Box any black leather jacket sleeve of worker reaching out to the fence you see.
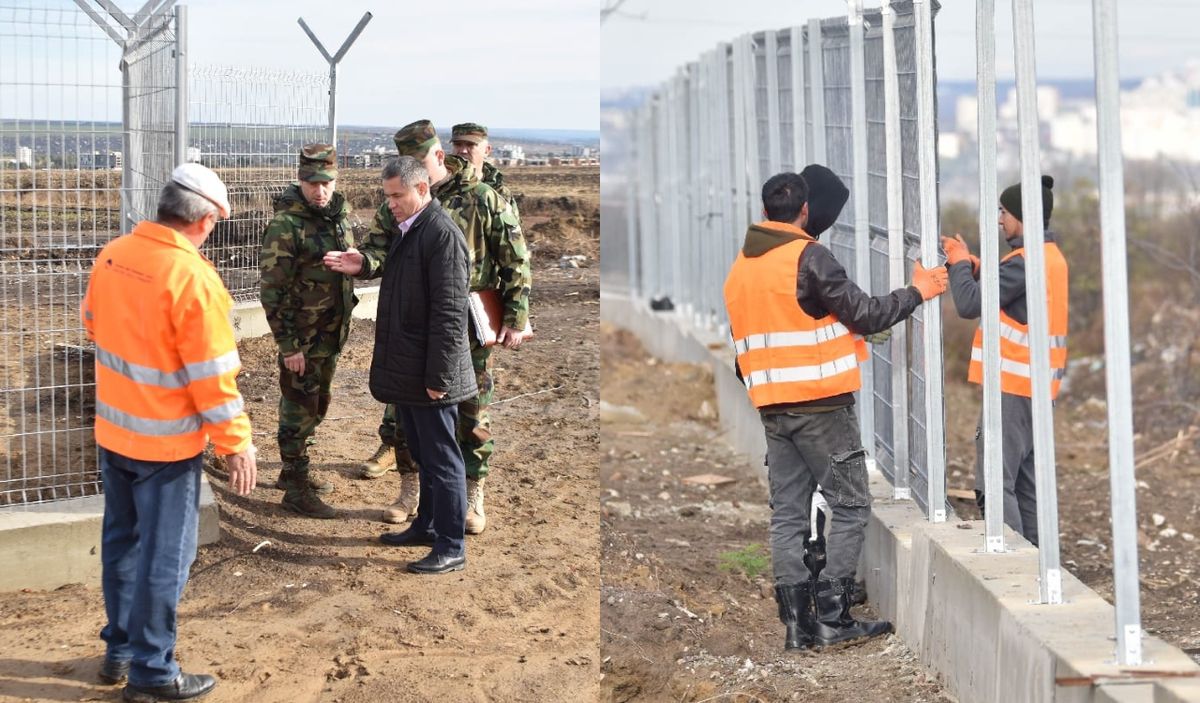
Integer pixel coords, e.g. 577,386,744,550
796,245,923,335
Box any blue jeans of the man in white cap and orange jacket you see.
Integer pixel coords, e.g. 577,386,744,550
100,447,202,686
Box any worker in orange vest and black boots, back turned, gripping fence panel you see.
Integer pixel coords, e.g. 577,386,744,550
725,164,947,649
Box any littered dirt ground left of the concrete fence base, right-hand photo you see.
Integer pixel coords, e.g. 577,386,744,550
600,324,954,703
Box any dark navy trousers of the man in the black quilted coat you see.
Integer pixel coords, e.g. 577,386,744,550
396,405,467,557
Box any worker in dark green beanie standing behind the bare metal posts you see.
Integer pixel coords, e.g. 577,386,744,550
942,175,1068,546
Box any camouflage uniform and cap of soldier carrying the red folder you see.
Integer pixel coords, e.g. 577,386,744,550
359,126,532,479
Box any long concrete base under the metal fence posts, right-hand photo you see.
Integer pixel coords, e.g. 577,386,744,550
600,293,1200,703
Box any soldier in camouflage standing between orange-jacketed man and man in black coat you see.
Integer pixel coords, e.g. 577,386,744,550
259,144,358,518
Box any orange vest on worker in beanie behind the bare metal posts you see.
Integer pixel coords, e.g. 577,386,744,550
967,241,1067,399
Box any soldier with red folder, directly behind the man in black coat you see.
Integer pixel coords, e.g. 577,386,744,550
359,120,532,534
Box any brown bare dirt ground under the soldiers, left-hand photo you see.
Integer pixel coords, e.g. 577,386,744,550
0,169,600,703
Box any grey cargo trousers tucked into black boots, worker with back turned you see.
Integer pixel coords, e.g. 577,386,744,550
762,407,871,585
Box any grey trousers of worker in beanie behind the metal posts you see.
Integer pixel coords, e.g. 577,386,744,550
976,393,1038,547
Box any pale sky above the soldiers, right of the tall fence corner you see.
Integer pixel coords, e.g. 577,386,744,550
188,0,600,130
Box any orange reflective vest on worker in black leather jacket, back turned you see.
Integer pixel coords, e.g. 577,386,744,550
725,222,870,408
